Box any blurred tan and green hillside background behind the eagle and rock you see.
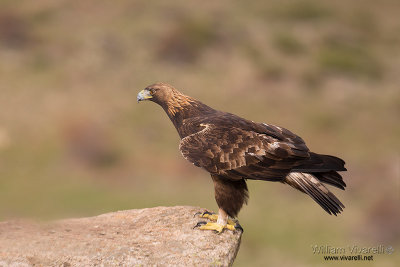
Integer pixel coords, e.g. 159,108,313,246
0,0,400,266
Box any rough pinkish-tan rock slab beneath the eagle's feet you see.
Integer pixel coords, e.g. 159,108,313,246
0,207,242,266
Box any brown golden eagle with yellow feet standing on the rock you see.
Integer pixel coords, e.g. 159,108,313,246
137,83,346,233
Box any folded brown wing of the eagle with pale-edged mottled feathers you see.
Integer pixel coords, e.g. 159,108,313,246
179,124,309,181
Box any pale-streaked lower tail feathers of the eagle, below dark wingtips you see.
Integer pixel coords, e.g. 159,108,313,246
284,172,344,216
